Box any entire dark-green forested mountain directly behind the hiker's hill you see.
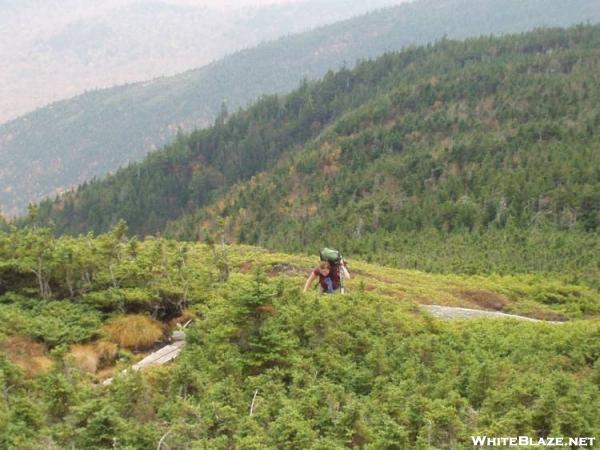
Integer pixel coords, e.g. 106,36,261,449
31,26,600,287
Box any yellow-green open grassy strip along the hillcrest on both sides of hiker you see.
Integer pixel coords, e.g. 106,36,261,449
226,246,600,320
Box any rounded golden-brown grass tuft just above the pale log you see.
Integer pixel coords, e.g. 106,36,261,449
104,314,163,350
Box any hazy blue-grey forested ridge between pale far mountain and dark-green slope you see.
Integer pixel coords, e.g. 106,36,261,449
0,0,600,214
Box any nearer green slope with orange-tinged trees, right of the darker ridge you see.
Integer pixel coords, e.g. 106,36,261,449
169,27,600,287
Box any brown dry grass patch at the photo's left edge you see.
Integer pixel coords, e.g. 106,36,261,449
0,336,52,377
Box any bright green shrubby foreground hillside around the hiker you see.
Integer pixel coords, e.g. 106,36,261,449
0,225,600,450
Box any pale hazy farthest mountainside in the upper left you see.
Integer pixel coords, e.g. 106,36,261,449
0,0,402,123
